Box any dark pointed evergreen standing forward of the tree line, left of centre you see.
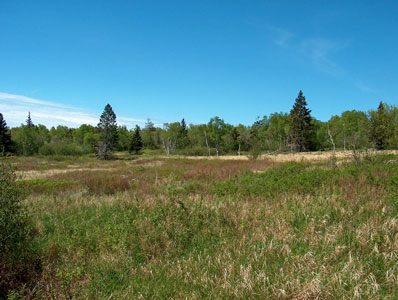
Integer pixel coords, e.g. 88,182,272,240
97,104,117,159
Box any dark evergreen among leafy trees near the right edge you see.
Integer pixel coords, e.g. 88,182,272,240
370,101,393,150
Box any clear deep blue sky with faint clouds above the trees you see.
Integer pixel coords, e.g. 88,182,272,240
0,0,398,128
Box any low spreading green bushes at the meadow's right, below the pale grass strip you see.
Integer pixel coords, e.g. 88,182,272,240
213,159,398,198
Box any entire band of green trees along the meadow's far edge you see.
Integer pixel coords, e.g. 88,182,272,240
0,91,398,159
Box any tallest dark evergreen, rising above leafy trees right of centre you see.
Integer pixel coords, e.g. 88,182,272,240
289,90,313,152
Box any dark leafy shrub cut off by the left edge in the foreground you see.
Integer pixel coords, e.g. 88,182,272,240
0,162,40,298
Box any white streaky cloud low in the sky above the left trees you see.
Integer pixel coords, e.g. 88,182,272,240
0,92,154,128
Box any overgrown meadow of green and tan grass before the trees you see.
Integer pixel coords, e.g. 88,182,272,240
4,154,398,299
